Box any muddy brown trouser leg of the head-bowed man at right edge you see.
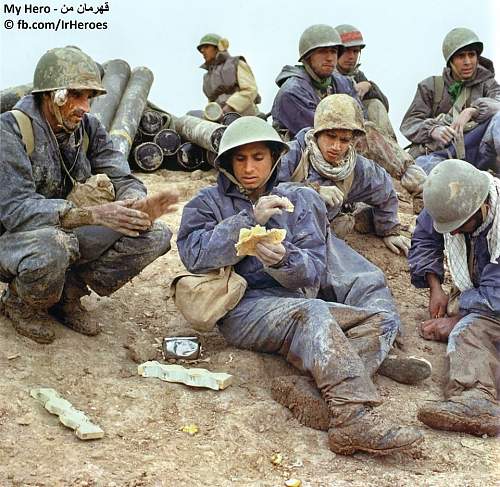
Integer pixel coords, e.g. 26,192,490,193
444,313,500,400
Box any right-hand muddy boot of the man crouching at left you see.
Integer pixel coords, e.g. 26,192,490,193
50,273,101,336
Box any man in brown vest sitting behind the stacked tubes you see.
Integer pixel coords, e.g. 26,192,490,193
191,34,260,115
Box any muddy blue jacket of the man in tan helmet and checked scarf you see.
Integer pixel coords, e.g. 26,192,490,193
278,128,399,237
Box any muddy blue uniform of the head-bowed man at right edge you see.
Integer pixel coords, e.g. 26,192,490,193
409,210,500,399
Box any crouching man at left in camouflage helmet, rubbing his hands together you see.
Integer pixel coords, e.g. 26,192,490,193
0,47,176,343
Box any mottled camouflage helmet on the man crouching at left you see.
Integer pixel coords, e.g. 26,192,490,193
32,46,106,95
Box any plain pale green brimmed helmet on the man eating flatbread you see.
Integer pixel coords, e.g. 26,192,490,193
215,117,288,167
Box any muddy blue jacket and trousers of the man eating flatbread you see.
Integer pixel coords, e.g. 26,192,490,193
177,166,400,406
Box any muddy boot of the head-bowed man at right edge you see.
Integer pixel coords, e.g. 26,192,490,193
417,395,500,436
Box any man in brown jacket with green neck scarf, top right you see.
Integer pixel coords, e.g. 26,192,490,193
401,27,500,173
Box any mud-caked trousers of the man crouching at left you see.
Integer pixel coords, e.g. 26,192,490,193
0,222,172,308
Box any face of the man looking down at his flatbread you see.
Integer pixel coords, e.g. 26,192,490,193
231,142,273,190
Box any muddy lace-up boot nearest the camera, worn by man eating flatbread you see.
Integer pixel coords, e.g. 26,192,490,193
328,405,423,455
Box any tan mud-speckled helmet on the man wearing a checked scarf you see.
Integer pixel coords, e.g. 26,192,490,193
314,94,365,135
